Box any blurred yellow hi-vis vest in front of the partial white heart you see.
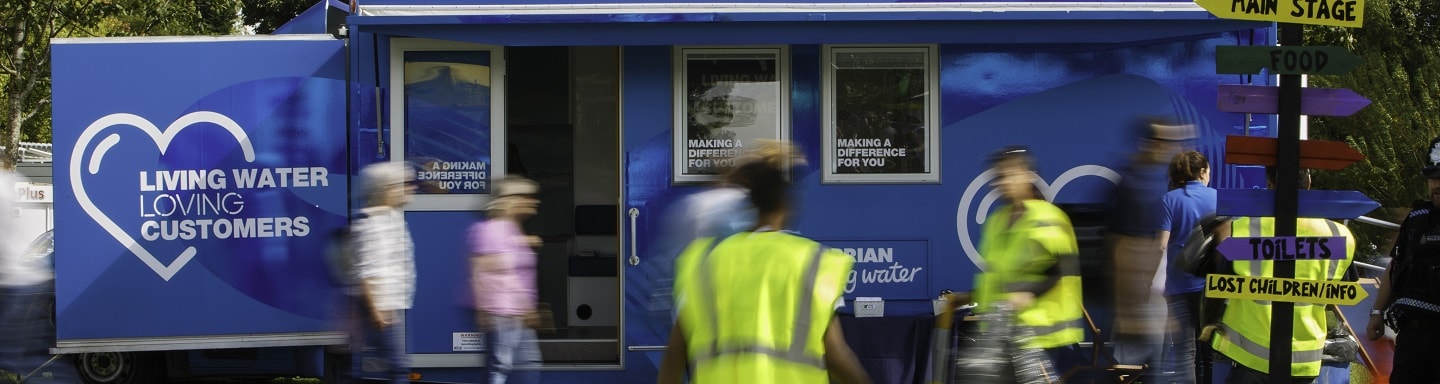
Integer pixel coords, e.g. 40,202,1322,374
975,200,1084,348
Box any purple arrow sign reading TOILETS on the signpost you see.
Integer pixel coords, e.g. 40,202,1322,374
1215,236,1345,262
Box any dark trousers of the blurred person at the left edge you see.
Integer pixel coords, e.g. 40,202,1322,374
0,283,81,383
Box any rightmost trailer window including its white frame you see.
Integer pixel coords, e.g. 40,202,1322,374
821,46,940,183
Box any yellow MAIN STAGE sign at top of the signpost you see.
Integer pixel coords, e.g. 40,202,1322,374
1195,0,1365,27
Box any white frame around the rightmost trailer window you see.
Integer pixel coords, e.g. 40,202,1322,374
821,45,940,184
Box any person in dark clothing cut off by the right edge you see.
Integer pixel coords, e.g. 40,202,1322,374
1367,137,1440,384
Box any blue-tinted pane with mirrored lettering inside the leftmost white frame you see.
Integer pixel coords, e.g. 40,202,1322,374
405,50,491,194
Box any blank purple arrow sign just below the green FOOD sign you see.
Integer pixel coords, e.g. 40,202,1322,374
1215,85,1369,116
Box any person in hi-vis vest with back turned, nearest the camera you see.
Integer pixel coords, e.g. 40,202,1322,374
658,143,870,384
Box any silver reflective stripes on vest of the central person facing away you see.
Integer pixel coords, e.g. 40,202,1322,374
694,240,827,370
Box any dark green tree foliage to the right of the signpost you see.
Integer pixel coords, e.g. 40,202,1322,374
1306,0,1440,260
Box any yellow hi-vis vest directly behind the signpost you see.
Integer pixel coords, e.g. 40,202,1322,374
1211,217,1355,377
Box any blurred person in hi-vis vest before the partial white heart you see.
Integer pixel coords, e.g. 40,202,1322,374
973,147,1084,377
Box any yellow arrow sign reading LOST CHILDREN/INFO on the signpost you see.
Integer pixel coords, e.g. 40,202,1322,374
1205,275,1369,305
